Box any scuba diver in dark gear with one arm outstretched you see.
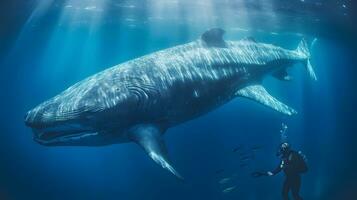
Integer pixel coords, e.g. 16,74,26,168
252,142,308,200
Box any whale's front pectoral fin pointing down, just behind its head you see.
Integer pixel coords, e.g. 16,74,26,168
129,124,183,179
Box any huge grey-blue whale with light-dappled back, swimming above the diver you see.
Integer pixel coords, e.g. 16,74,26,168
24,28,317,179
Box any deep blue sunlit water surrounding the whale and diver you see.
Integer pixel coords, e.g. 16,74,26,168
0,0,357,200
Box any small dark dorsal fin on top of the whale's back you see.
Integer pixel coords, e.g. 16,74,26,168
201,28,226,47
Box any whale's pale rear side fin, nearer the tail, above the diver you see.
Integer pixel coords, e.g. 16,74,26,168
236,85,297,115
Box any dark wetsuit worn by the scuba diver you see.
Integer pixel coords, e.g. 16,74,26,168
268,151,302,200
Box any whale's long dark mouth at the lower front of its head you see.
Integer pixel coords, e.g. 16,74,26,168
32,126,98,145
